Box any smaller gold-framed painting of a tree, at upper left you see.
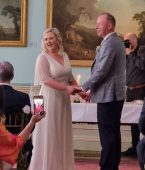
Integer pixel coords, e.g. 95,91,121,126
0,0,27,47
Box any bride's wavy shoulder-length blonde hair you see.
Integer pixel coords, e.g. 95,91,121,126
42,27,64,55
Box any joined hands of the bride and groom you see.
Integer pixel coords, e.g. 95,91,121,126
67,85,90,101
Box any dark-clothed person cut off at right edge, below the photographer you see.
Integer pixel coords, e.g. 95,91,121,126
137,99,145,170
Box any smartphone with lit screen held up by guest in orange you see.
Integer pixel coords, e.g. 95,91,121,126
33,95,44,115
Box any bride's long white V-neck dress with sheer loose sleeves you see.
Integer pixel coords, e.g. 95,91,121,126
29,53,74,170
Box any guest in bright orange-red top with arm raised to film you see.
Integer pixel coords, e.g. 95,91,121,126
0,86,45,170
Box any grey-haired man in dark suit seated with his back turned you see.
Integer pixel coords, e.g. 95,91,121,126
0,61,33,165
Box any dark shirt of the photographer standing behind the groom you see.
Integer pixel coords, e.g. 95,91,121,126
126,46,145,86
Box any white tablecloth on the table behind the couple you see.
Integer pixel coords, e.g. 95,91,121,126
71,103,142,124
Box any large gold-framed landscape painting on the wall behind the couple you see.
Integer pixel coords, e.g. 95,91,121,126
46,0,145,66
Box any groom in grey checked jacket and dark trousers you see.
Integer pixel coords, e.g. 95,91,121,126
82,13,126,170
